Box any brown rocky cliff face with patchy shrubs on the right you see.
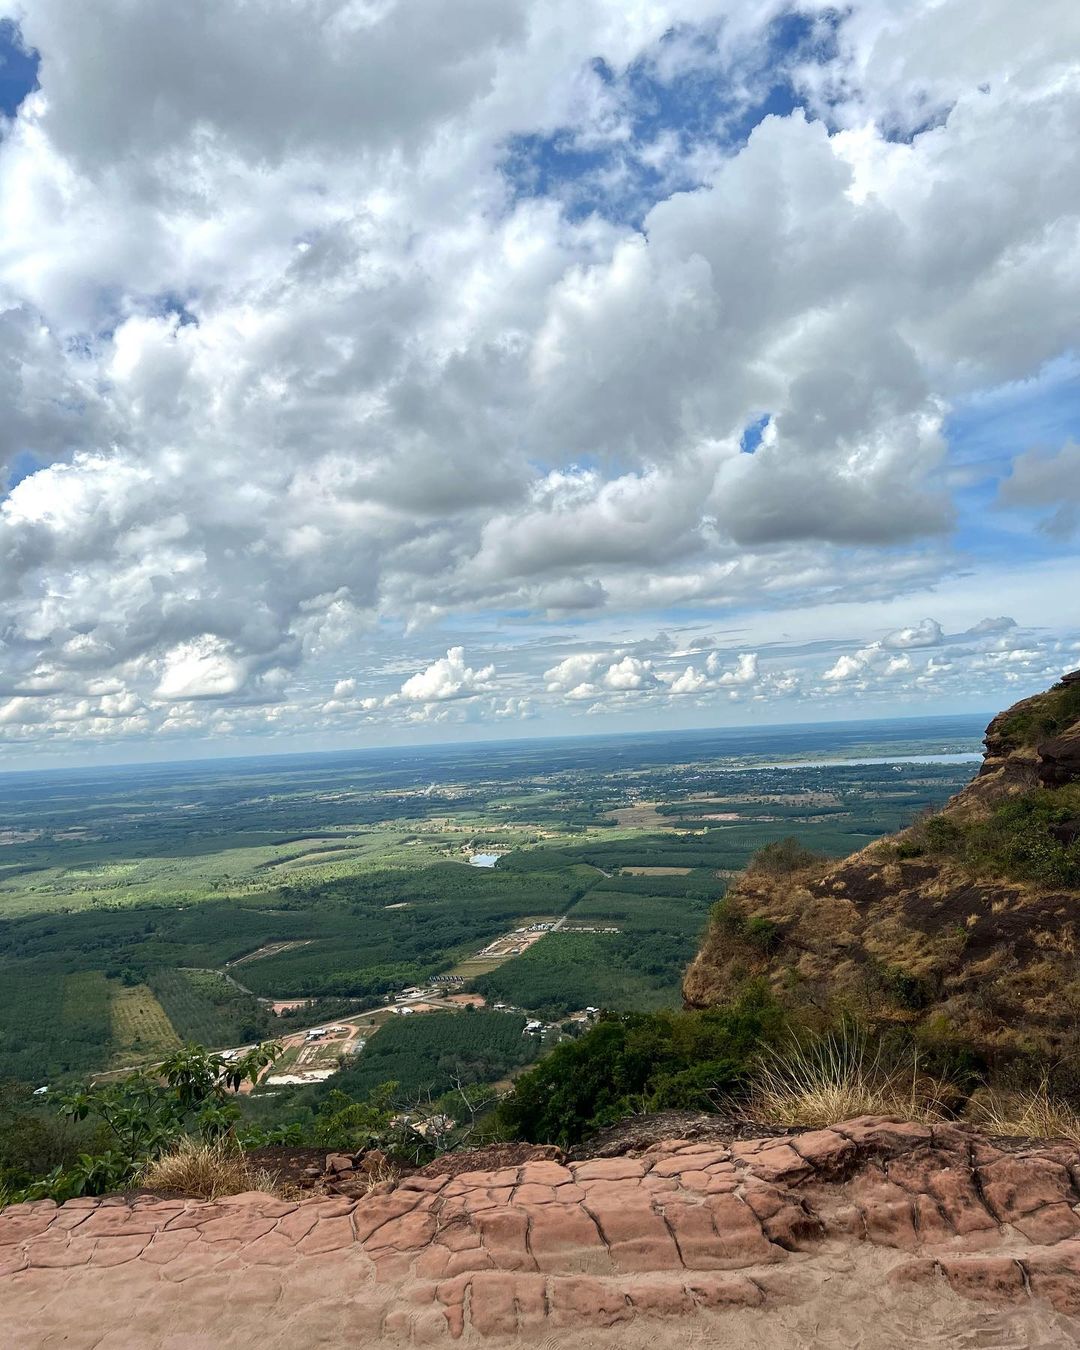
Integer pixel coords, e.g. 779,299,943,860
683,671,1080,1058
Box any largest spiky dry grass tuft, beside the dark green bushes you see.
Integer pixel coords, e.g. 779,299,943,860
749,1026,945,1127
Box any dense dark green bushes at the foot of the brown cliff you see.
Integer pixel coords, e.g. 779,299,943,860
498,987,782,1146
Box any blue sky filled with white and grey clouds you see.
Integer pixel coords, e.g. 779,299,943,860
0,0,1080,768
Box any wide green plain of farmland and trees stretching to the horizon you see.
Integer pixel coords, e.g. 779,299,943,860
0,720,977,1083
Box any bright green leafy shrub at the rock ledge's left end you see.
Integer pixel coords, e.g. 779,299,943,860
10,1045,278,1200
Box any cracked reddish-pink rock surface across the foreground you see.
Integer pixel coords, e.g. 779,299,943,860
0,1116,1080,1350
